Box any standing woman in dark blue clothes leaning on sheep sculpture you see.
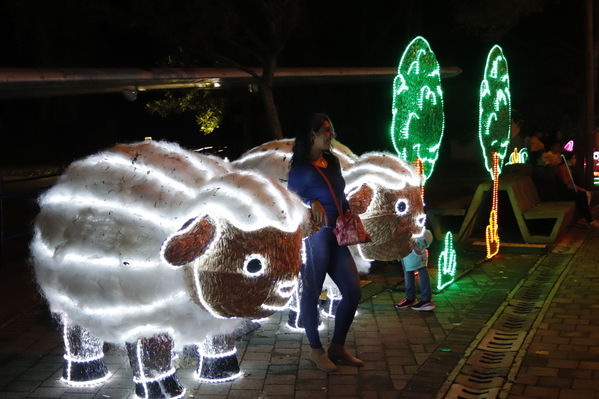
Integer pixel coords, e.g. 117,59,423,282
288,114,364,371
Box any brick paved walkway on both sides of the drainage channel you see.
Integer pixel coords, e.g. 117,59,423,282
0,223,599,399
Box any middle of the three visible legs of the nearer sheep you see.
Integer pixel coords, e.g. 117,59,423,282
127,335,185,399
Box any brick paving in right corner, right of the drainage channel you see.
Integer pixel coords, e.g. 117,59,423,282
508,230,599,399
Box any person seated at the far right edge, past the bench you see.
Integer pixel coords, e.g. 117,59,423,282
557,152,599,227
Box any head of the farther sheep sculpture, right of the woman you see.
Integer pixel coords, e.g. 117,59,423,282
344,153,426,260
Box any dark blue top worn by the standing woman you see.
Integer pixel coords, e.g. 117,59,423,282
287,153,349,227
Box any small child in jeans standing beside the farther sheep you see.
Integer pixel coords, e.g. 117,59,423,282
395,230,436,311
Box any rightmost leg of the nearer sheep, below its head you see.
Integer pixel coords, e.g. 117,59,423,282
196,334,241,382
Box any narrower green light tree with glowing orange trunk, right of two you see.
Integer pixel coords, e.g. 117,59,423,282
478,45,512,259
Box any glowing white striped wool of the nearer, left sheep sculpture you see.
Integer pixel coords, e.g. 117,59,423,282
31,141,305,348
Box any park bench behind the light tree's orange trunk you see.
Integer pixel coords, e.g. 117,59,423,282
458,175,575,244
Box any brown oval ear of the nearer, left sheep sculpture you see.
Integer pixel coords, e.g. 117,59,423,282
162,216,216,266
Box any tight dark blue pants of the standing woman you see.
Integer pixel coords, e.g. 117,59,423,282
300,227,362,349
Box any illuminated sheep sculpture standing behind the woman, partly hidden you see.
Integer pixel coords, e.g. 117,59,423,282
233,139,426,328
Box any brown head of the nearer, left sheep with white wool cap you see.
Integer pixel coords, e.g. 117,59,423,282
163,172,306,318
